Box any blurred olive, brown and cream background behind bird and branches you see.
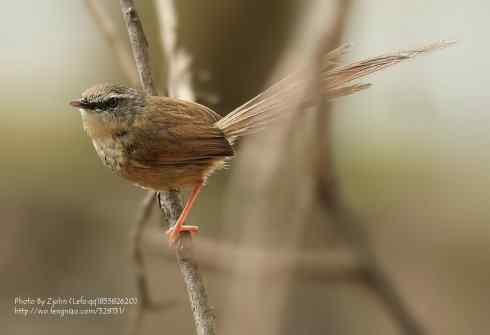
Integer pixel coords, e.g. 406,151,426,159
0,0,490,334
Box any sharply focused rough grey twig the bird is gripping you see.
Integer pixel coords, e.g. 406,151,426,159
120,0,215,335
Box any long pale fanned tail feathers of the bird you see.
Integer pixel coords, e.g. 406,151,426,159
216,41,454,143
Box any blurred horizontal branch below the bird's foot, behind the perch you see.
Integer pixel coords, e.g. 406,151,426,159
146,234,363,283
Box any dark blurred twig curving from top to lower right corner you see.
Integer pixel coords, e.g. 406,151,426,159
316,0,425,335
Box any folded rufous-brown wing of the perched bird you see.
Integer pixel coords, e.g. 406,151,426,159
131,97,234,166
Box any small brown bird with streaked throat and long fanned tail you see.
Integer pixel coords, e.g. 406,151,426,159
70,42,450,243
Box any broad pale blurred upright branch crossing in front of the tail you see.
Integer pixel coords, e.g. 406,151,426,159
222,1,342,334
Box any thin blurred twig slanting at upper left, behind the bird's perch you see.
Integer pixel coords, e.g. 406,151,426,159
85,0,138,85
